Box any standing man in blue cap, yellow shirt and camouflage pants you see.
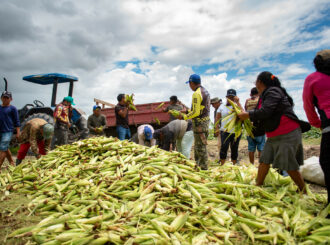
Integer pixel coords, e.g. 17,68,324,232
180,74,210,170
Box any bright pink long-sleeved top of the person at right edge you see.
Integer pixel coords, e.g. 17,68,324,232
303,72,330,128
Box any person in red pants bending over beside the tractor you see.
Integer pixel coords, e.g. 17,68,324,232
16,118,54,165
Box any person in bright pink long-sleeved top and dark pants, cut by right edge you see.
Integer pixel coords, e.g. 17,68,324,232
303,49,330,207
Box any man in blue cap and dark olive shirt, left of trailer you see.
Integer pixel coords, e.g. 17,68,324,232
87,105,107,136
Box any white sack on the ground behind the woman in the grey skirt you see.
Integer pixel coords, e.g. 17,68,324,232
300,156,325,186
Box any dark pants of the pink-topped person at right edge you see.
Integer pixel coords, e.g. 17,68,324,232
320,132,330,203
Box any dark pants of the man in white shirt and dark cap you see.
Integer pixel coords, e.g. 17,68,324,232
220,132,242,161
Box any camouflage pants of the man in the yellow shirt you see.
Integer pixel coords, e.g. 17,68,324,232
193,119,210,170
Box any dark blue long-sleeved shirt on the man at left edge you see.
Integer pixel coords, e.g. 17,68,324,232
0,105,20,133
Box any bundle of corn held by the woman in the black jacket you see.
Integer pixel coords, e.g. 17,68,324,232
222,99,254,139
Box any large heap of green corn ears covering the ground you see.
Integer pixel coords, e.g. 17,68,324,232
0,137,330,245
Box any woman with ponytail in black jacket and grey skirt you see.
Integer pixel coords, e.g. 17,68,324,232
238,71,306,192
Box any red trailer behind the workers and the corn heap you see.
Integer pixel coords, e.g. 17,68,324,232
94,99,188,136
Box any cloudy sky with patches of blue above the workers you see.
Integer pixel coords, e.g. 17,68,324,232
0,0,330,120
